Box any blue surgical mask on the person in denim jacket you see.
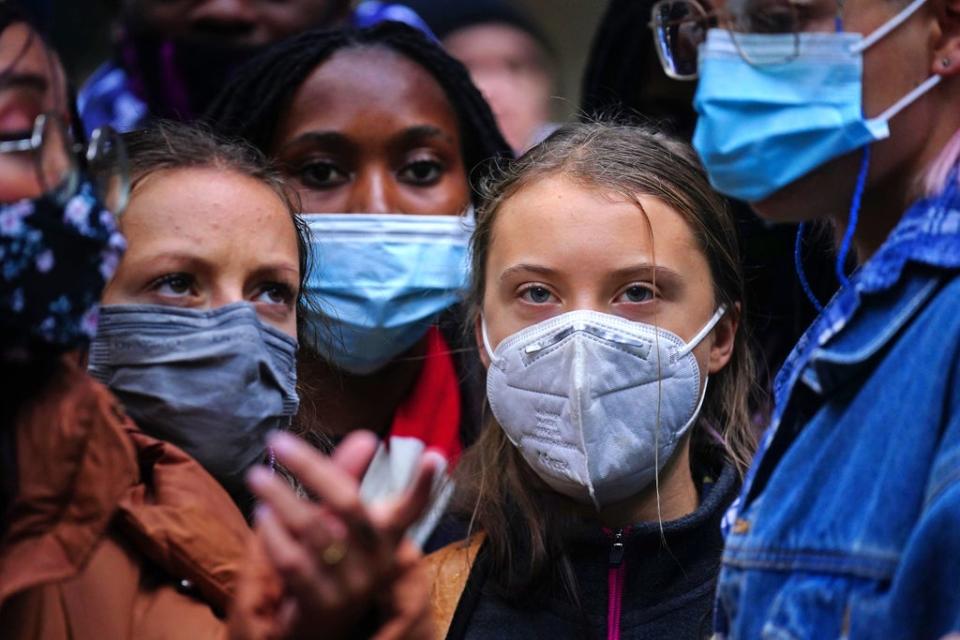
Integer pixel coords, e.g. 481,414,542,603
693,0,940,202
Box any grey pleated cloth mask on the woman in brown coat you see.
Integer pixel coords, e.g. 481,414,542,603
89,303,299,498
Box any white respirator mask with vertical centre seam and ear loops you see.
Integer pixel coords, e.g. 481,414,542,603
483,307,725,510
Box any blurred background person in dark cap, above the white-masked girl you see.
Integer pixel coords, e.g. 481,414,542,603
402,0,557,153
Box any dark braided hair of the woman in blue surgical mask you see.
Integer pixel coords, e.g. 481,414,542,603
206,22,513,200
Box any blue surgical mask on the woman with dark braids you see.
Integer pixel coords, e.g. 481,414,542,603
304,213,473,375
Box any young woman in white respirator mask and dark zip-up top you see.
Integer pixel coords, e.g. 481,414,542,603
428,124,754,638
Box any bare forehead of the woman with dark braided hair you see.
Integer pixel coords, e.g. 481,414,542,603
276,46,459,141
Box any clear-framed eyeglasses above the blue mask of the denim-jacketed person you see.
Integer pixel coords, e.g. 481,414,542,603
649,0,840,80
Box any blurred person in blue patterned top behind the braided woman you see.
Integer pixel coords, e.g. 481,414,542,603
79,0,432,132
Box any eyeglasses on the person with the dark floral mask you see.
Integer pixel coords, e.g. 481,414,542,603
0,113,130,215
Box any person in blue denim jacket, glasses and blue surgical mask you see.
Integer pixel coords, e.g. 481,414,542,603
652,0,960,638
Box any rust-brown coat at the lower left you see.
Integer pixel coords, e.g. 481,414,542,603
0,360,250,640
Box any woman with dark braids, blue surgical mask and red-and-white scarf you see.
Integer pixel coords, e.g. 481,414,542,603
209,23,510,544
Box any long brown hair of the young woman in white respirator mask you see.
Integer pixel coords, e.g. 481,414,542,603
454,122,756,598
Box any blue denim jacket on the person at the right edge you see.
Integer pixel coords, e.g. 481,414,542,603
715,181,960,640
